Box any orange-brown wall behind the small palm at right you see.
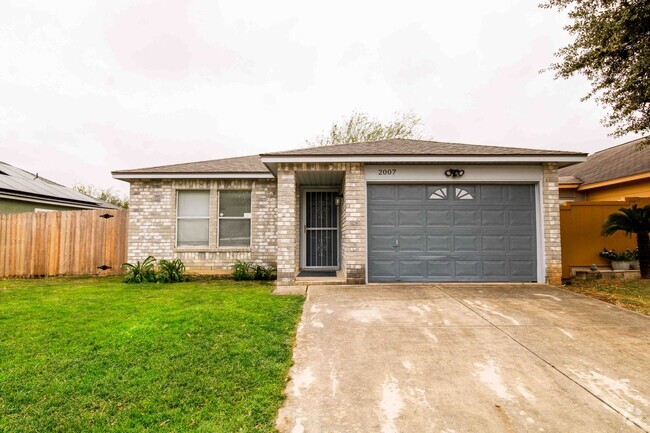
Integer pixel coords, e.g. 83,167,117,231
560,198,650,278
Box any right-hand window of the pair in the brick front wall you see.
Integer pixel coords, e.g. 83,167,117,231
219,191,251,247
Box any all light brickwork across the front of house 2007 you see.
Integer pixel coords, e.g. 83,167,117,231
129,163,562,284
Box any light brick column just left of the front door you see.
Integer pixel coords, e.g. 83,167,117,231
277,164,298,285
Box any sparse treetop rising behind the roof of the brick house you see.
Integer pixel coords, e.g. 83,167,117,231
307,111,422,146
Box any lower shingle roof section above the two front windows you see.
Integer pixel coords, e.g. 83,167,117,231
113,155,270,175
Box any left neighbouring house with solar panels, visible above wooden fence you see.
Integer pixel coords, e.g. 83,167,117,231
0,161,116,214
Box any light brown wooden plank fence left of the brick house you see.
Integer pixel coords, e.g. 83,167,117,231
0,209,128,277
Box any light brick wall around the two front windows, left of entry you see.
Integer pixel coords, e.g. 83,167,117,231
128,179,277,270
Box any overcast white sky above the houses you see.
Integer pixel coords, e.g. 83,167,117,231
0,0,635,192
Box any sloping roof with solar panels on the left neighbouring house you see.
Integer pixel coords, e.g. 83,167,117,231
0,161,112,207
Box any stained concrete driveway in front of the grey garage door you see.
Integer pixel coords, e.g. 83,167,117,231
277,284,650,433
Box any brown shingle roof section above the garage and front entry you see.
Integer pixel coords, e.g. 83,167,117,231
262,138,585,157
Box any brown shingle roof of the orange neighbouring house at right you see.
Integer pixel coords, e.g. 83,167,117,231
559,139,650,185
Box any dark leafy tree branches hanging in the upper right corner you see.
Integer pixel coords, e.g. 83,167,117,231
540,0,650,149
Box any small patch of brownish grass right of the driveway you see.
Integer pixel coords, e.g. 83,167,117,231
565,279,650,316
